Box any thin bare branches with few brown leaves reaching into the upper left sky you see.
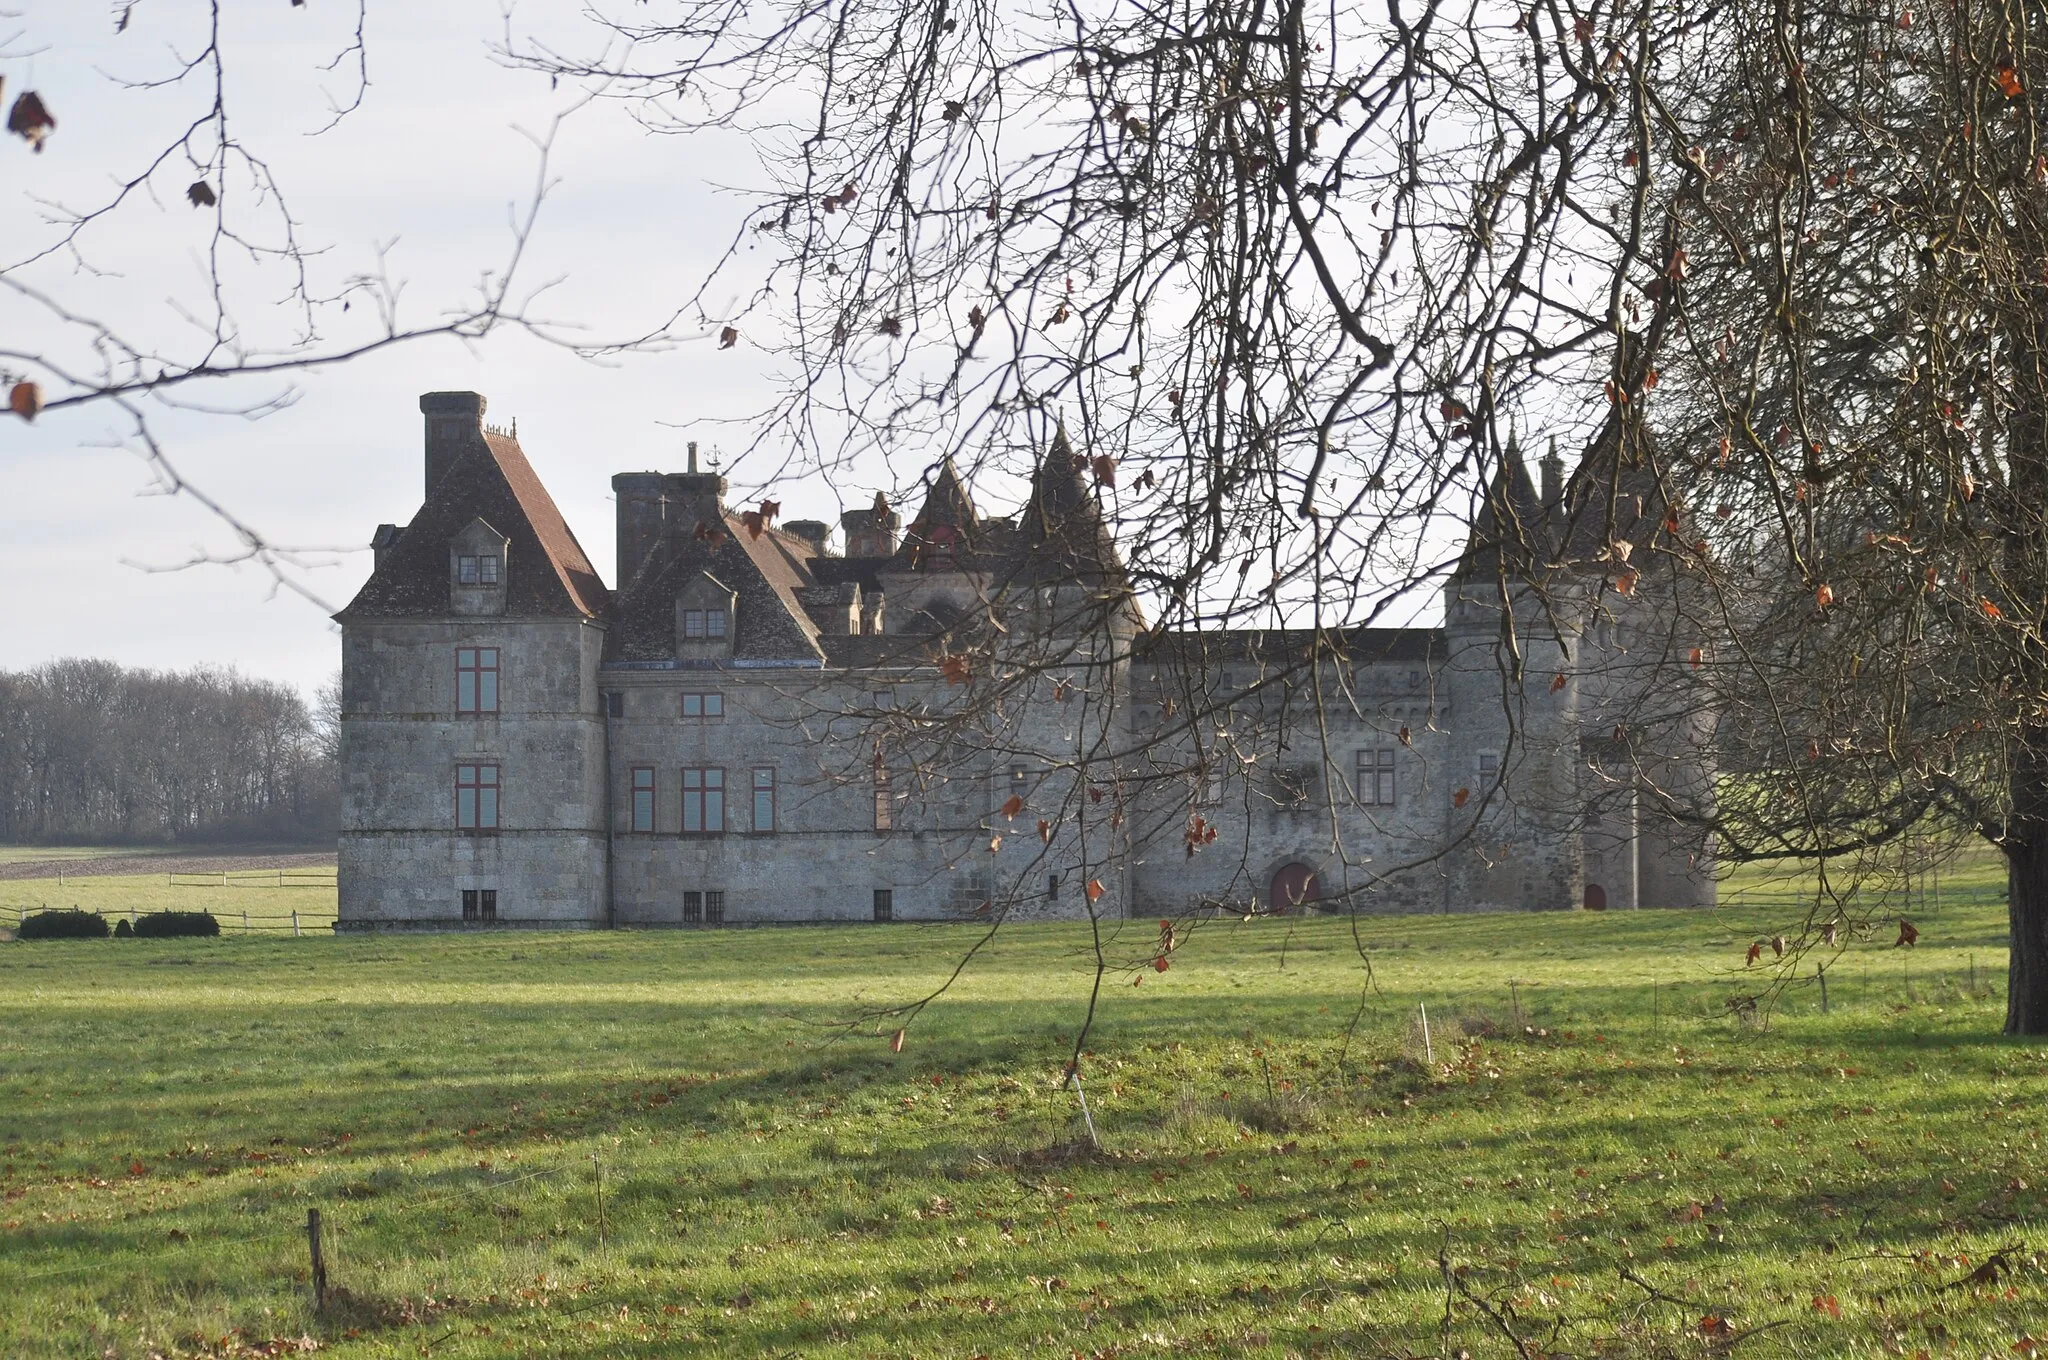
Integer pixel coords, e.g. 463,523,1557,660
0,0,589,604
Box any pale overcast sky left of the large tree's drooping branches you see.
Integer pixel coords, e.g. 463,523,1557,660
0,0,815,686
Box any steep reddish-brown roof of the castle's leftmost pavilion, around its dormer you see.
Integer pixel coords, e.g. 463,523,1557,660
336,430,610,623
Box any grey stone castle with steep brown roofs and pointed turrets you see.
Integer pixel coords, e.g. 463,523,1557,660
338,393,1714,930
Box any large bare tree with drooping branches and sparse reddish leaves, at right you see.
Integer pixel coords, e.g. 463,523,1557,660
508,0,2048,1032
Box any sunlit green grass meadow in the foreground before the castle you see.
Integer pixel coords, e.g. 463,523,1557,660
0,866,2048,1360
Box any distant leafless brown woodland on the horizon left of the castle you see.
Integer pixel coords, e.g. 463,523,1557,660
0,660,338,844
